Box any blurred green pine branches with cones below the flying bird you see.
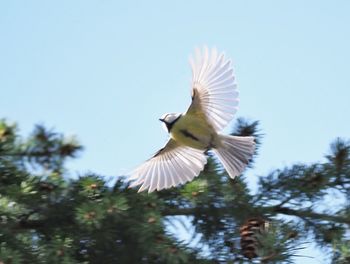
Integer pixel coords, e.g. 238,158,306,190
0,119,350,264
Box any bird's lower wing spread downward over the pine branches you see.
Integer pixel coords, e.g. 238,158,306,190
129,139,207,192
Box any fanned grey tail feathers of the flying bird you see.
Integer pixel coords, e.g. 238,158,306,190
213,135,255,179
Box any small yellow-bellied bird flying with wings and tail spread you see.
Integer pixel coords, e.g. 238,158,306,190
128,46,255,193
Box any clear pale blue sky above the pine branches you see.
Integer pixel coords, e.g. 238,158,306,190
0,0,350,263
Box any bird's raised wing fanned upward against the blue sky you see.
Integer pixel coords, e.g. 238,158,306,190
187,47,238,131
